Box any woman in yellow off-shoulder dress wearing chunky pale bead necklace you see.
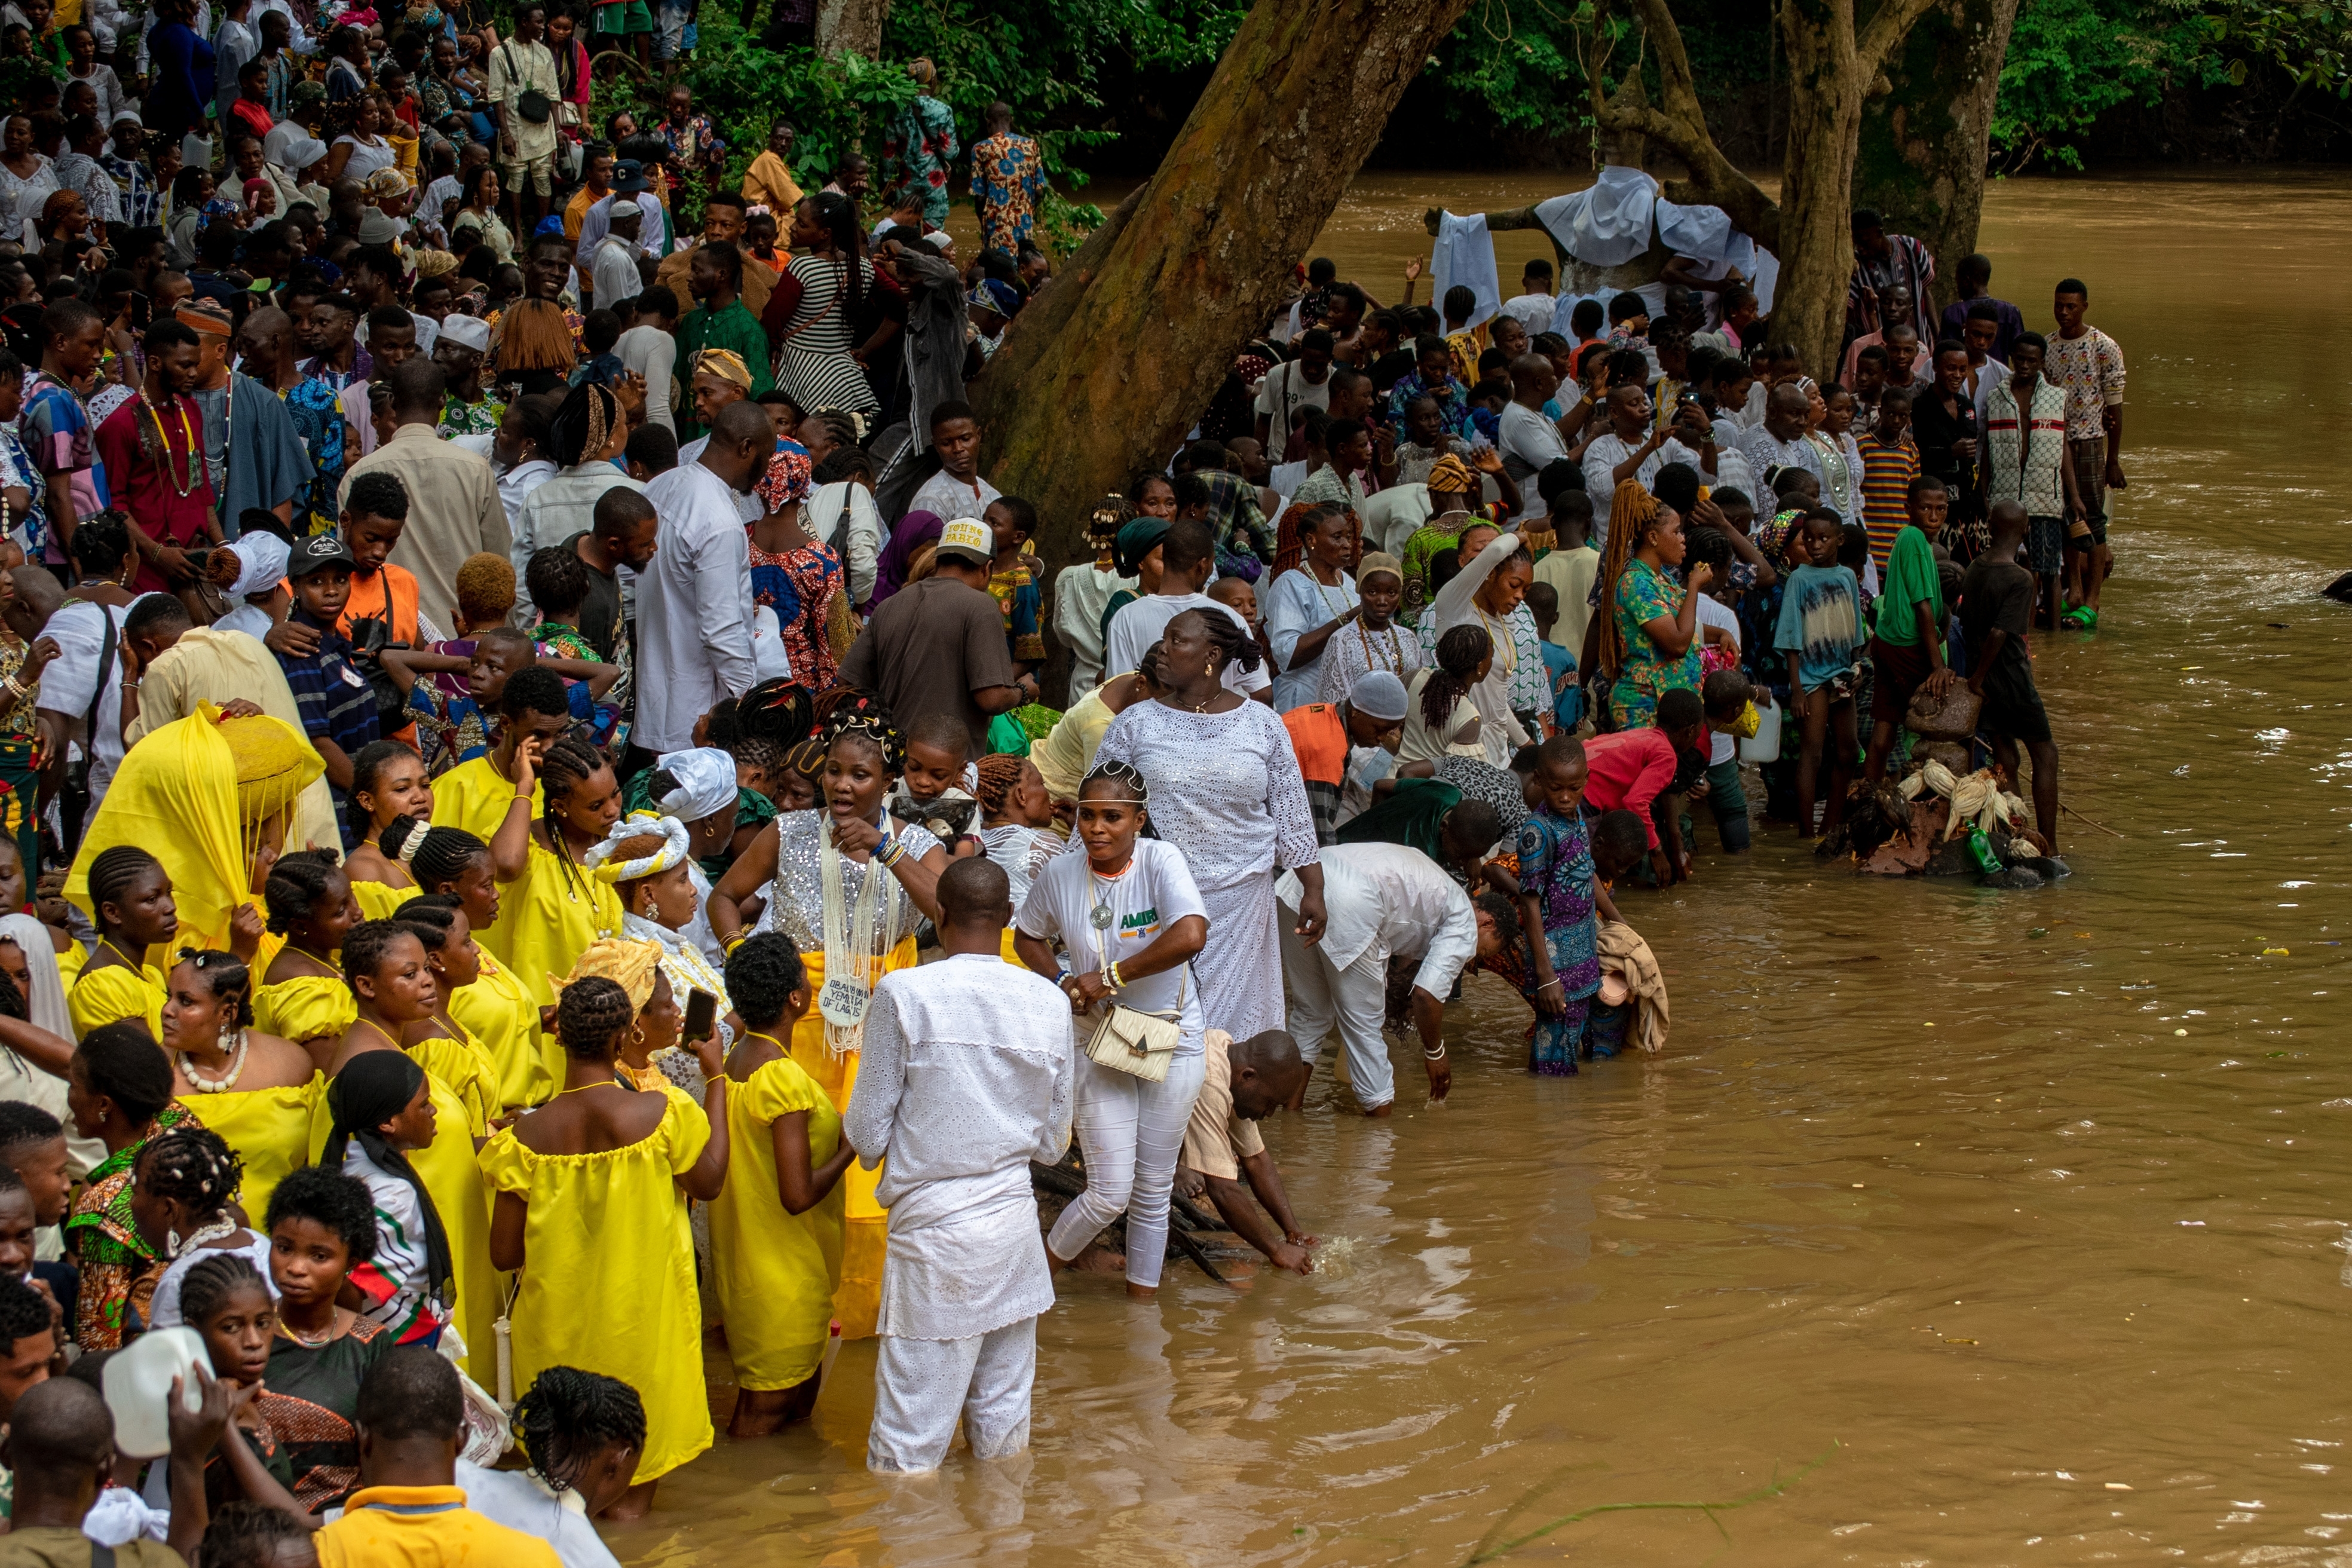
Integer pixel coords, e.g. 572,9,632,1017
163,952,327,1215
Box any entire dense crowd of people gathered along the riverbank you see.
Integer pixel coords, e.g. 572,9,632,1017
0,0,2124,1568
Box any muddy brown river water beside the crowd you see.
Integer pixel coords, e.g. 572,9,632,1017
616,172,2352,1568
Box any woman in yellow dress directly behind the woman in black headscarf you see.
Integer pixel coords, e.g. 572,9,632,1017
311,919,498,1387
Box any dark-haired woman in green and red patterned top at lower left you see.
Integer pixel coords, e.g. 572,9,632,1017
66,1020,202,1352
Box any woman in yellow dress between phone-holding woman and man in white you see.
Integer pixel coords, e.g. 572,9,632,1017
710,931,856,1439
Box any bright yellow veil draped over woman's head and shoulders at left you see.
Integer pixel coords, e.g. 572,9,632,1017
66,703,327,947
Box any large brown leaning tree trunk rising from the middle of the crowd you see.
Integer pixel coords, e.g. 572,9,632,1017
972,0,1468,564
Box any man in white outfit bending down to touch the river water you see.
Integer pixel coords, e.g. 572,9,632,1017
1275,844,1480,1117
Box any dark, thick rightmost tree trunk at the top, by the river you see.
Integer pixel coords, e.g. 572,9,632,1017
1854,0,2018,308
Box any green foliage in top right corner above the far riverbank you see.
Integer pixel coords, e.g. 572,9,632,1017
1992,0,2352,174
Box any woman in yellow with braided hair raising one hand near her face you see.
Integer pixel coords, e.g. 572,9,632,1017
475,736,621,1043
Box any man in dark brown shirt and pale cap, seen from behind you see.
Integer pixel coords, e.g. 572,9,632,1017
842,517,1037,757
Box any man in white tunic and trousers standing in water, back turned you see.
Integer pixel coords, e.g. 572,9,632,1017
842,856,1077,1469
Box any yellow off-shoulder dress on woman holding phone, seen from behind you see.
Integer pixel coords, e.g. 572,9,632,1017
482,1086,710,1481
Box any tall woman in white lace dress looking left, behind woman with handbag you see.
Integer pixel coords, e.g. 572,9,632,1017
1094,609,1324,1039
